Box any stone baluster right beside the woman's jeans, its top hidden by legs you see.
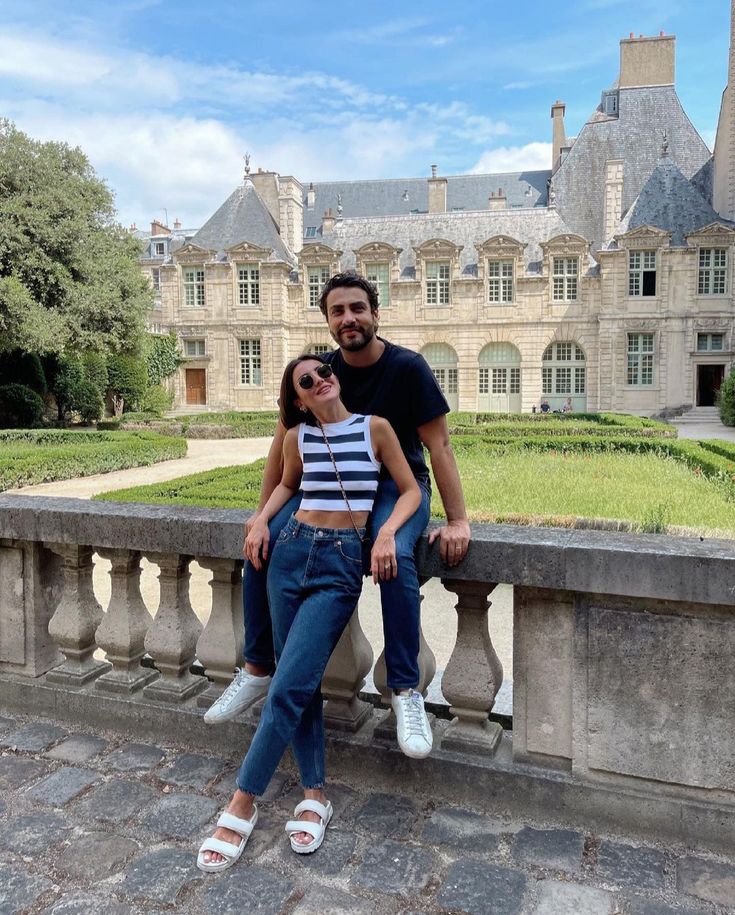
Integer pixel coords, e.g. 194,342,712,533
322,609,373,732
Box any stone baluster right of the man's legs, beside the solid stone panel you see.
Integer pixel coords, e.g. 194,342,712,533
442,578,503,756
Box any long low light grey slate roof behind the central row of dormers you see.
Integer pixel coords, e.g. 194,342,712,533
318,207,593,279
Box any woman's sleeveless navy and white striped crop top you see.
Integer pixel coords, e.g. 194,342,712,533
298,413,380,512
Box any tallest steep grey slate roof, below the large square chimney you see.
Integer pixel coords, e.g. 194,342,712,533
553,86,712,250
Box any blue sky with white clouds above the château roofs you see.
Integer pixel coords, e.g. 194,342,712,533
0,0,730,227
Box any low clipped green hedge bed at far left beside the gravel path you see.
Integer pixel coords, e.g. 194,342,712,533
0,429,186,492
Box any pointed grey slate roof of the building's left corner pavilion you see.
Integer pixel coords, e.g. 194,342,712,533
191,181,294,264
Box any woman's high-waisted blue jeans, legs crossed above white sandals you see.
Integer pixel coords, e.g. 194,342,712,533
237,517,362,795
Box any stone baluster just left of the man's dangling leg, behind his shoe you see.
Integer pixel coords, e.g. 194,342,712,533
197,558,245,708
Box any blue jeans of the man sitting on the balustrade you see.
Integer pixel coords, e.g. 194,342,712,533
242,479,430,689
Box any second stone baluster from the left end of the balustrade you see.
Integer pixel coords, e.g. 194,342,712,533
94,549,158,694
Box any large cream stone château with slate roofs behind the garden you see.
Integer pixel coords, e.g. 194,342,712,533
137,22,735,415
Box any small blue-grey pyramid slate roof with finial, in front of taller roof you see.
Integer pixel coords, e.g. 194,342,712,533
616,156,727,246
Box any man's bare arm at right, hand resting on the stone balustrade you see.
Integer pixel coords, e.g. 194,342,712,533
417,415,471,566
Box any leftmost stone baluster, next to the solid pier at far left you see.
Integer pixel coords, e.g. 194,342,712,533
46,543,110,686
